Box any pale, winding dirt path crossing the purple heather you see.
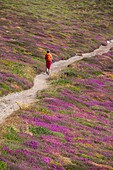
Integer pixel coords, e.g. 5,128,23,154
0,40,113,123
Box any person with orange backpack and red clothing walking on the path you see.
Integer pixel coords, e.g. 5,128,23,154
45,50,53,75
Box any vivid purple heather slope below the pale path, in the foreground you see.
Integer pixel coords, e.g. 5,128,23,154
0,46,113,170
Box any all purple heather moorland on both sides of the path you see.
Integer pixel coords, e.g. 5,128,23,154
0,0,113,170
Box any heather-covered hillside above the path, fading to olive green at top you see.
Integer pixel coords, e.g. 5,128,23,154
0,0,113,96
